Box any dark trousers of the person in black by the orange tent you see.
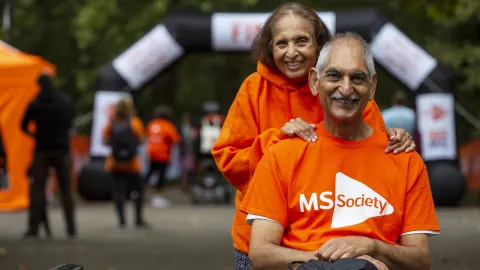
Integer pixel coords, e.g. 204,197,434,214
28,151,76,235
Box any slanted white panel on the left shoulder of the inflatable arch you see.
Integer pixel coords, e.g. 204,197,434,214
112,24,184,89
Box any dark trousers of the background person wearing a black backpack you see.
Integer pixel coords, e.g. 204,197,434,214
112,172,144,225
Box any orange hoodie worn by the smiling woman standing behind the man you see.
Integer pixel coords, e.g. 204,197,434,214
212,62,386,253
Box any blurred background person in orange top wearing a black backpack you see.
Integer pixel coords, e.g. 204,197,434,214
103,99,148,228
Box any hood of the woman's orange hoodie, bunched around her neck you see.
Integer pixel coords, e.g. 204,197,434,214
257,61,318,118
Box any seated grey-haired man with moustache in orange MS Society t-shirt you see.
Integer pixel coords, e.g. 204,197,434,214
241,33,440,269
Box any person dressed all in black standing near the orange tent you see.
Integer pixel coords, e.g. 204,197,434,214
22,74,76,237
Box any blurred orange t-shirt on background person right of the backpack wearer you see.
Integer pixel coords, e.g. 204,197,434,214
147,119,180,162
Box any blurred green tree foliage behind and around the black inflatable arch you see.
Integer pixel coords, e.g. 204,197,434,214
0,0,480,139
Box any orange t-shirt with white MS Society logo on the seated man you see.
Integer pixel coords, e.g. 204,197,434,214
241,124,440,251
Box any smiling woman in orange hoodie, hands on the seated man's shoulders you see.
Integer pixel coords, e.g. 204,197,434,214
212,2,415,270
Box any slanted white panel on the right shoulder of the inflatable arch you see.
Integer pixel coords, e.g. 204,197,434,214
370,23,437,91
